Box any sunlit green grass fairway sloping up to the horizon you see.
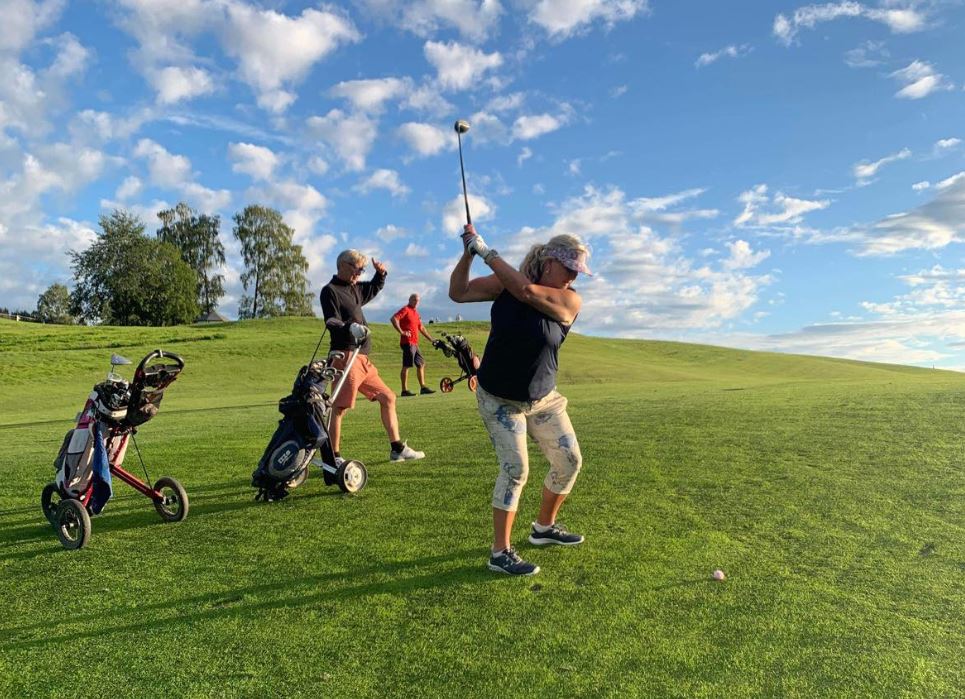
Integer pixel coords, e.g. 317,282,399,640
0,320,965,697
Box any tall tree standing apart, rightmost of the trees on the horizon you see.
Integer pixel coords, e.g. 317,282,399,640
234,205,313,318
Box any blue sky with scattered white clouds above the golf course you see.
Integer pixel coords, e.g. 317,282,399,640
0,0,965,369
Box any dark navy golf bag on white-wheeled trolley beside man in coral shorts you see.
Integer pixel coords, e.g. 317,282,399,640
251,323,368,502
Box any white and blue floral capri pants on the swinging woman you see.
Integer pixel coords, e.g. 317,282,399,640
476,386,583,512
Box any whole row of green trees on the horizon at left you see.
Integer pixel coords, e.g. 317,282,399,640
33,202,313,325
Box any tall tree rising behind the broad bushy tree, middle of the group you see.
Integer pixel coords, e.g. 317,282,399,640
157,202,225,314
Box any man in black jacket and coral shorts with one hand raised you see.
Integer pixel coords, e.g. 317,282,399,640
321,250,425,461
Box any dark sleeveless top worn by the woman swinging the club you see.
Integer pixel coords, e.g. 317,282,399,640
479,291,570,401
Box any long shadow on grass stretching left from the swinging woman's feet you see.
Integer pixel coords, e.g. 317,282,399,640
0,549,504,651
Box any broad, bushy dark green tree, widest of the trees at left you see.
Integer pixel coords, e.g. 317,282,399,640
70,211,199,325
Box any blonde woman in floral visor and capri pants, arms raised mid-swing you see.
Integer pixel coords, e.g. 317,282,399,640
449,223,590,575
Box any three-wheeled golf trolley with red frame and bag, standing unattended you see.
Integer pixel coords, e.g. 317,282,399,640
40,349,188,549
